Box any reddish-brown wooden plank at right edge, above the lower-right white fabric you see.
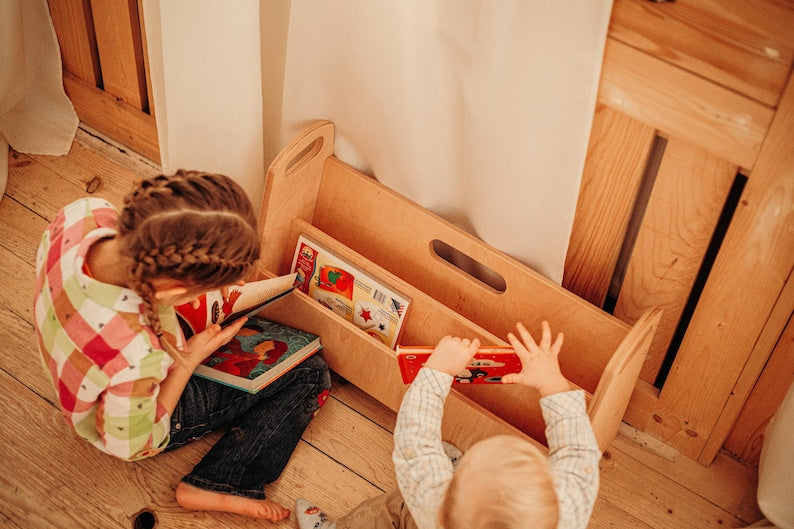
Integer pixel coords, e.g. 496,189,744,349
725,312,794,465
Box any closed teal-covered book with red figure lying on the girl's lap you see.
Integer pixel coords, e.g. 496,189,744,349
194,316,322,393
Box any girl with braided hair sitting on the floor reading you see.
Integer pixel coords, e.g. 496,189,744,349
34,170,330,521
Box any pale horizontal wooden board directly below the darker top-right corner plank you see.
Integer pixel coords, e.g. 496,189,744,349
598,38,773,168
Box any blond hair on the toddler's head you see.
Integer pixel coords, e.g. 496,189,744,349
439,435,559,529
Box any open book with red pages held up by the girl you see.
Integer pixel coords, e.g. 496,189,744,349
174,274,295,339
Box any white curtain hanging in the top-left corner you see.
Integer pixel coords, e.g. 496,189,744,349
0,0,79,198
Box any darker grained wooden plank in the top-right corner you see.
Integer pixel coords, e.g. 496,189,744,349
609,0,794,107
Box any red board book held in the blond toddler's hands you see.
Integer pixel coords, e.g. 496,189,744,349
397,345,521,384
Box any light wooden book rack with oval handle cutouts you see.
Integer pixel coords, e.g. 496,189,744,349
259,121,661,450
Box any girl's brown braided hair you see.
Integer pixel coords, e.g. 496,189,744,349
118,169,260,342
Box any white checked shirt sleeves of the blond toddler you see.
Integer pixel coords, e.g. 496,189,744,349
393,368,601,529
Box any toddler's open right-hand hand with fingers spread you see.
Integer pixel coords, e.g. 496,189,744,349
502,321,571,397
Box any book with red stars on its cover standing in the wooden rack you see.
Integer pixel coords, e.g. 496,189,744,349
291,235,411,349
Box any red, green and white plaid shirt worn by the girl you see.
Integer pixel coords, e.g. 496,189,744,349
34,198,180,460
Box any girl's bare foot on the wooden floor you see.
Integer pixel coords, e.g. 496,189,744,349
176,482,289,522
